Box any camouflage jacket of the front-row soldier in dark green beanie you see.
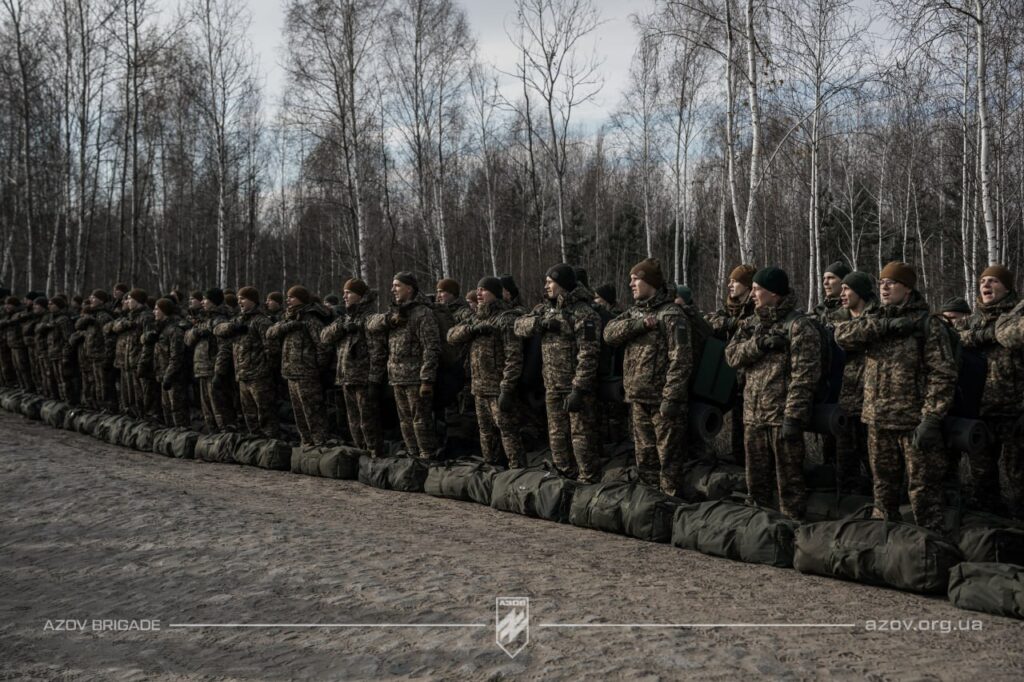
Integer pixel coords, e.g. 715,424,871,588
725,292,821,426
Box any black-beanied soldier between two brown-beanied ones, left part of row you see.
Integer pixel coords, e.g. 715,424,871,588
185,287,237,433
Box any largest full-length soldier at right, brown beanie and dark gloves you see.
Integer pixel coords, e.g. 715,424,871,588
836,261,957,531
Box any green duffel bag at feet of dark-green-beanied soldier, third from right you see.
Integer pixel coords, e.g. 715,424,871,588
672,500,800,568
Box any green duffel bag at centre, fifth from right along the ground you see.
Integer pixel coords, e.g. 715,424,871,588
490,465,579,523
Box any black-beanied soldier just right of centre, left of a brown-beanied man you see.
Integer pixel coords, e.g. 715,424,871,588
515,263,601,483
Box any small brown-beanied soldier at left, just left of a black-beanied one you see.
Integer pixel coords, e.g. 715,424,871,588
145,298,191,427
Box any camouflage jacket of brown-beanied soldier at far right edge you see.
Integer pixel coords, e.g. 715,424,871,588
959,293,1024,417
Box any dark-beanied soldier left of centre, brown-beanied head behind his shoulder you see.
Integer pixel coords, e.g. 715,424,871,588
367,272,441,459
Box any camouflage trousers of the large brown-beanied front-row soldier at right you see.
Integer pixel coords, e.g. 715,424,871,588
867,424,946,532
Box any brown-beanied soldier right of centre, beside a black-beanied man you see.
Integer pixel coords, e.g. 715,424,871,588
604,258,693,496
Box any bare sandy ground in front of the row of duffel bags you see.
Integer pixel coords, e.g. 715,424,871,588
0,405,1024,680
